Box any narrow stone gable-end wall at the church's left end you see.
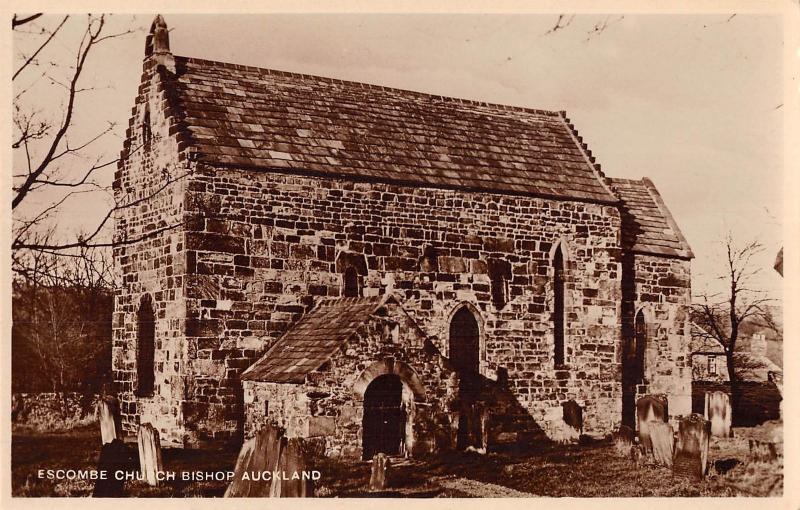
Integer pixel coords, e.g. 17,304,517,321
112,60,190,445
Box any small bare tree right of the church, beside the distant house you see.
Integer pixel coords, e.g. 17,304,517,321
693,233,773,409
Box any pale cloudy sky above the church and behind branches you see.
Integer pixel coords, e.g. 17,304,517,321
14,14,785,299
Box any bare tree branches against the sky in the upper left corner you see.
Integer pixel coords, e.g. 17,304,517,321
11,14,182,279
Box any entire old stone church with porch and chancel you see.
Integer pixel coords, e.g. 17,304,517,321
113,16,693,458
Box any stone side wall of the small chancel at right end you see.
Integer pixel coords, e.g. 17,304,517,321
634,254,692,416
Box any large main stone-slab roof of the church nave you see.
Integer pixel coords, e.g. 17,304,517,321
168,56,619,204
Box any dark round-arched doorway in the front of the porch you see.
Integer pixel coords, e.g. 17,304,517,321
362,374,407,460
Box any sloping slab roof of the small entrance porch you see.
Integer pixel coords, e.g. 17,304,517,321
241,295,390,384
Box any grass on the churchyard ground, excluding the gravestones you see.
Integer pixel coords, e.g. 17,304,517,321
12,426,783,498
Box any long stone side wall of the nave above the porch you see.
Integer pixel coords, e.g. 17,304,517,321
185,167,621,438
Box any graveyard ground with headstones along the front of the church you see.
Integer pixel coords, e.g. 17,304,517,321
12,392,783,498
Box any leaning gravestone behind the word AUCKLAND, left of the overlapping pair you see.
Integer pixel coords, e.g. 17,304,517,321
225,425,283,498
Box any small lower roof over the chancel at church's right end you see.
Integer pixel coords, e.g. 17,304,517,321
610,177,694,259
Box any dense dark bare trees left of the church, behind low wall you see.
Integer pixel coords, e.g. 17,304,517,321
12,230,113,393
